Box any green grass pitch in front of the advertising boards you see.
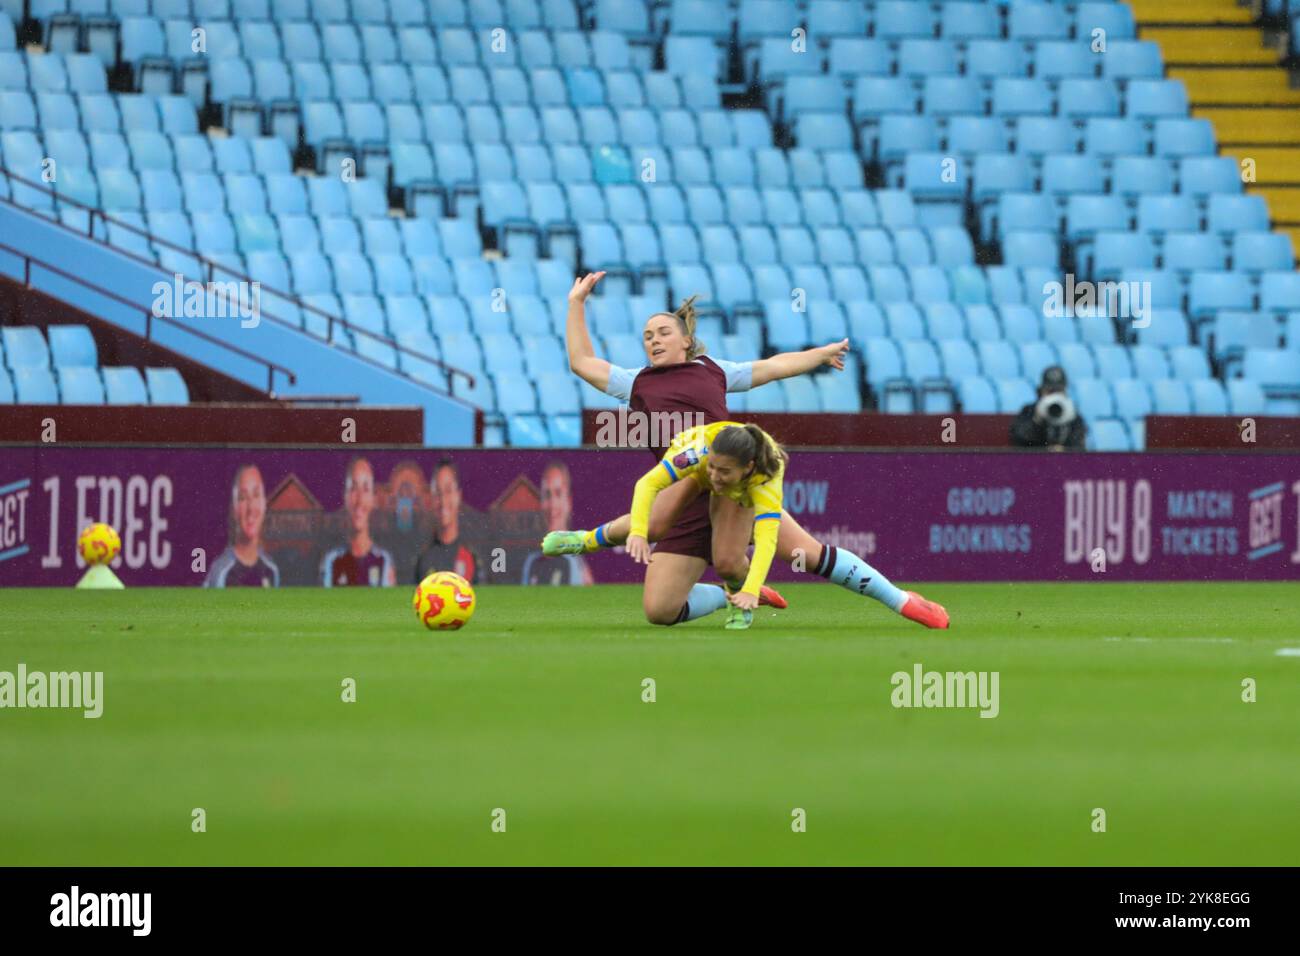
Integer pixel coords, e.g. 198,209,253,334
0,584,1300,865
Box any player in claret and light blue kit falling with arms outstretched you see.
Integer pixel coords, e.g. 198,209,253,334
542,272,948,628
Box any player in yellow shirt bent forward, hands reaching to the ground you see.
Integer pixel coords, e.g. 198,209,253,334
627,421,787,631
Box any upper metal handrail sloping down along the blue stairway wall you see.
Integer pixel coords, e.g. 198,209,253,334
0,165,475,394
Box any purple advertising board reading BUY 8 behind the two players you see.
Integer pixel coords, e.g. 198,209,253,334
0,445,1300,587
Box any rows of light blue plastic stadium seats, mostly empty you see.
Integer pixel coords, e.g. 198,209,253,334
0,0,1300,449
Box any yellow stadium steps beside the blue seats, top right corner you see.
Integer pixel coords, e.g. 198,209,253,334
1130,0,1300,248
